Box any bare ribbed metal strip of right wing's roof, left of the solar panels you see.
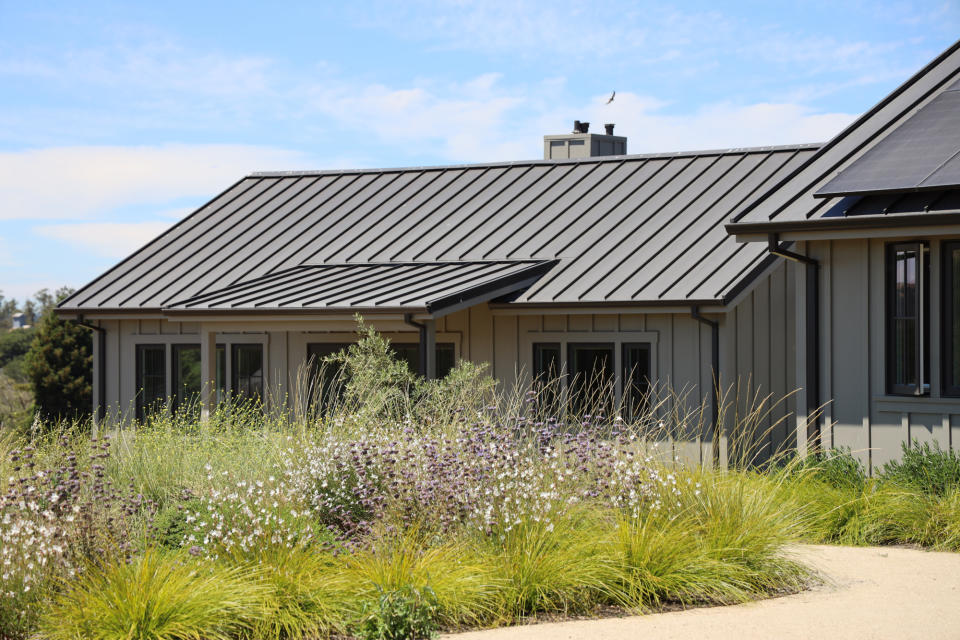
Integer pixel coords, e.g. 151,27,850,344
728,42,960,231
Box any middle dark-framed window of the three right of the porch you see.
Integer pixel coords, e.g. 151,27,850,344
567,342,614,415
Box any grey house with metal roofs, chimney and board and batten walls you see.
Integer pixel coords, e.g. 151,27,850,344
58,43,960,465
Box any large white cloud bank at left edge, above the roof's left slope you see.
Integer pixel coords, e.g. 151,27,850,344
0,144,311,220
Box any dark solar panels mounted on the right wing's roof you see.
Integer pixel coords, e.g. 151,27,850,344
816,88,960,196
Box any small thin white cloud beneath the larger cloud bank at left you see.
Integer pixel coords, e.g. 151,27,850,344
34,222,172,258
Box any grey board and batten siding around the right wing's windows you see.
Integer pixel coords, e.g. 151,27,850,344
798,237,960,473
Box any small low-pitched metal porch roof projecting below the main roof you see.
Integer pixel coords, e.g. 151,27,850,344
167,260,553,314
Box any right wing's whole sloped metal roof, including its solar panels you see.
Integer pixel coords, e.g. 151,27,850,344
727,41,960,228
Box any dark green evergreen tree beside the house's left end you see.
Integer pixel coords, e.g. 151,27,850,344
27,312,93,420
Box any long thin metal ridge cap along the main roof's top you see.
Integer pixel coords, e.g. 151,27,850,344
246,142,825,178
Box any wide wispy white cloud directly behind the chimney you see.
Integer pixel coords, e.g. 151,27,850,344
302,74,856,162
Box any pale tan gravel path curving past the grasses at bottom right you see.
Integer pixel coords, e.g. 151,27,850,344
446,546,960,640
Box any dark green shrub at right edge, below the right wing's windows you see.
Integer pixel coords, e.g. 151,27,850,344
879,440,960,497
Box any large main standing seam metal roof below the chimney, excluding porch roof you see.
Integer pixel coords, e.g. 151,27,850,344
60,145,817,311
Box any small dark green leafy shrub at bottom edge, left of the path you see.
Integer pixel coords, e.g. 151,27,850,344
357,585,437,640
